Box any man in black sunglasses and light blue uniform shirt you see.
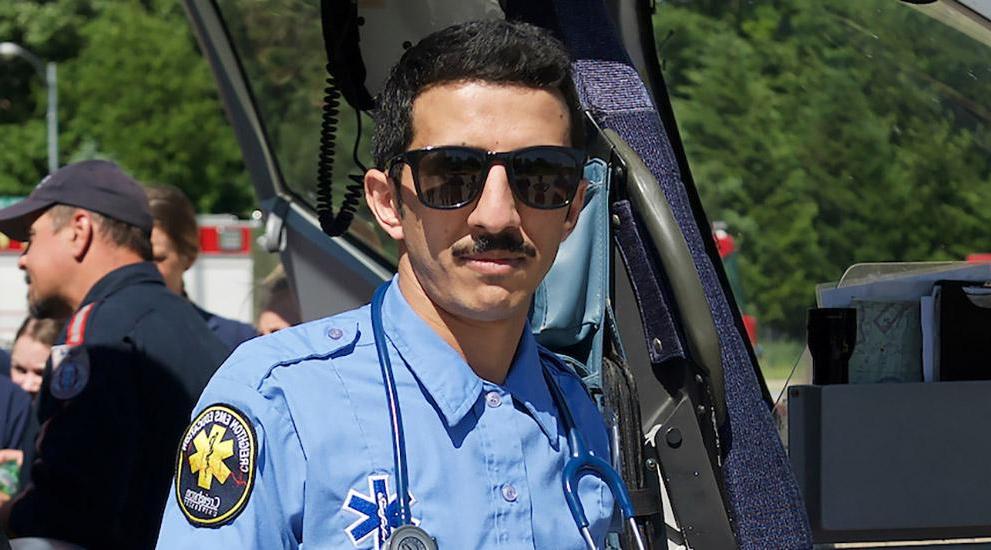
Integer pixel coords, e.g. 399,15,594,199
159,21,613,550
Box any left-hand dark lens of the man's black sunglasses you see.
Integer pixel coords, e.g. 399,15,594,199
419,148,485,208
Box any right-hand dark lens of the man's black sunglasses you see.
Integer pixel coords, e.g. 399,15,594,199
513,148,583,208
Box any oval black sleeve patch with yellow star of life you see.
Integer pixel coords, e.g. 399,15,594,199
175,403,258,527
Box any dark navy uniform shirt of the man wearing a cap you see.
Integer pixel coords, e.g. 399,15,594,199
10,262,227,548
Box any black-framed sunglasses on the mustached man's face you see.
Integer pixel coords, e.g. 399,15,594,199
387,145,587,210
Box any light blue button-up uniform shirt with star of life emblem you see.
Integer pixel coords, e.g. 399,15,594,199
158,279,613,550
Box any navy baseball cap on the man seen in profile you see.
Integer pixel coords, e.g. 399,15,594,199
0,160,154,241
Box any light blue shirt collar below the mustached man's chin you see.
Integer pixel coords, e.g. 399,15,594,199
382,275,558,449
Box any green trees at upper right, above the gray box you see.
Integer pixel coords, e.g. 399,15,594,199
655,0,991,336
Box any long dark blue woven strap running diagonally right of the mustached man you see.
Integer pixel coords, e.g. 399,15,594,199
553,0,812,549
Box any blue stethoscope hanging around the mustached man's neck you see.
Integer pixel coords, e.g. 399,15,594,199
371,282,645,550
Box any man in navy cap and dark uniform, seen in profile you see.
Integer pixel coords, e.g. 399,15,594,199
0,161,226,548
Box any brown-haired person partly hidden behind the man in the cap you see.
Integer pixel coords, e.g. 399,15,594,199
146,185,258,351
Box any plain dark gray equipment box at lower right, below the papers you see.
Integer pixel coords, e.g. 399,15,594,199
788,381,991,543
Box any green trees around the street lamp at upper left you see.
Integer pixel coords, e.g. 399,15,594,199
0,0,253,215
